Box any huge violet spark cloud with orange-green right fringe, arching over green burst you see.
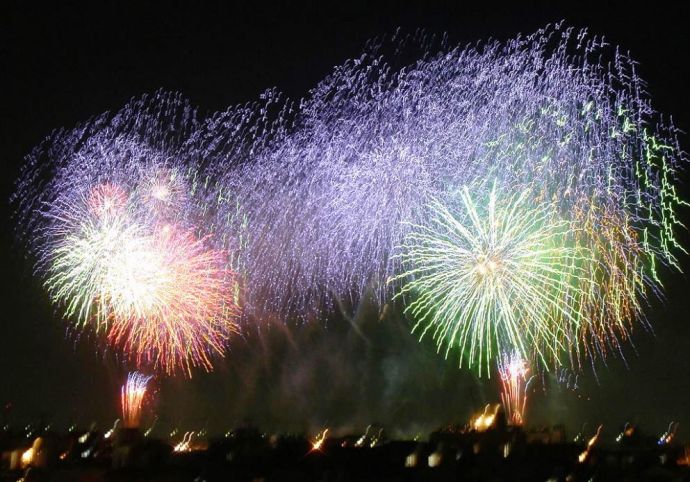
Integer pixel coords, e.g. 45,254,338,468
194,25,684,344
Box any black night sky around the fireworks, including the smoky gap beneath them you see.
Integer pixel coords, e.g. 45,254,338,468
0,0,690,439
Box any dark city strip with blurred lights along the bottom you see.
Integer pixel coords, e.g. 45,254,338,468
0,427,690,482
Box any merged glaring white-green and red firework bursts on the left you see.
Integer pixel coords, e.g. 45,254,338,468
46,183,236,375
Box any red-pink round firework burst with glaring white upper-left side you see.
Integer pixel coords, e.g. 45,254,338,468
106,226,236,376
